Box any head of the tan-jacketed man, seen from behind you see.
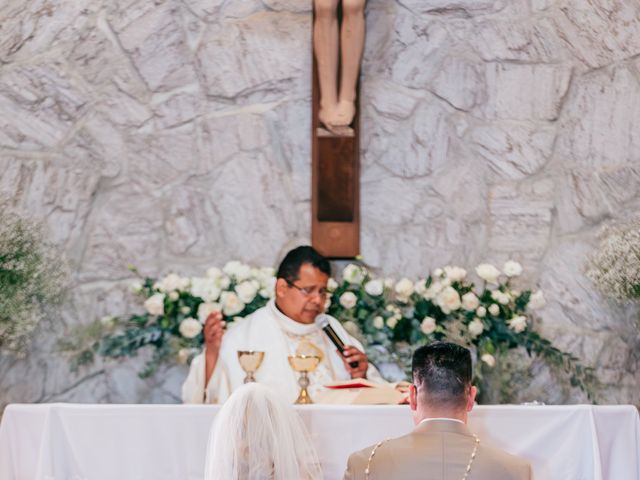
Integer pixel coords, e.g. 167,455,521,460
410,342,476,421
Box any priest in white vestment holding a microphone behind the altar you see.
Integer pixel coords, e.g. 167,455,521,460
182,246,383,403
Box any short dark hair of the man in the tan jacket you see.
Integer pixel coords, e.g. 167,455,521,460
411,342,472,408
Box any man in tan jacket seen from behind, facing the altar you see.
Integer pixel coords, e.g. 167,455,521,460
344,342,531,480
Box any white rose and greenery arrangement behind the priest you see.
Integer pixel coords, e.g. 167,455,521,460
80,261,586,402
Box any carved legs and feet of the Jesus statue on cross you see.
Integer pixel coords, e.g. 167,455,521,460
313,0,366,130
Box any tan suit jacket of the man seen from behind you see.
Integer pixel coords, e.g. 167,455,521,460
344,420,531,480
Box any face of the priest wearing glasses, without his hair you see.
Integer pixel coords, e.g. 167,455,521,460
276,263,329,323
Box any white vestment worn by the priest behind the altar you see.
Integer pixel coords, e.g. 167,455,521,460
182,300,384,403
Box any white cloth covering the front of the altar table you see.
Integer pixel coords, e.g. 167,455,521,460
0,404,640,480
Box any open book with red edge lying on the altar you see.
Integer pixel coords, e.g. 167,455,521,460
314,378,407,405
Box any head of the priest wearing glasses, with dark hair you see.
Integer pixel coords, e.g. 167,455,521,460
276,246,331,323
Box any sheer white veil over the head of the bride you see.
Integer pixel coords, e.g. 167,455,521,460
204,383,322,480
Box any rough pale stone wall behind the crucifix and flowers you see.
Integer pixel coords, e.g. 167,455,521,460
0,0,640,404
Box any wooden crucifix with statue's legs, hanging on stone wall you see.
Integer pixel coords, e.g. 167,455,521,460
311,0,366,258
